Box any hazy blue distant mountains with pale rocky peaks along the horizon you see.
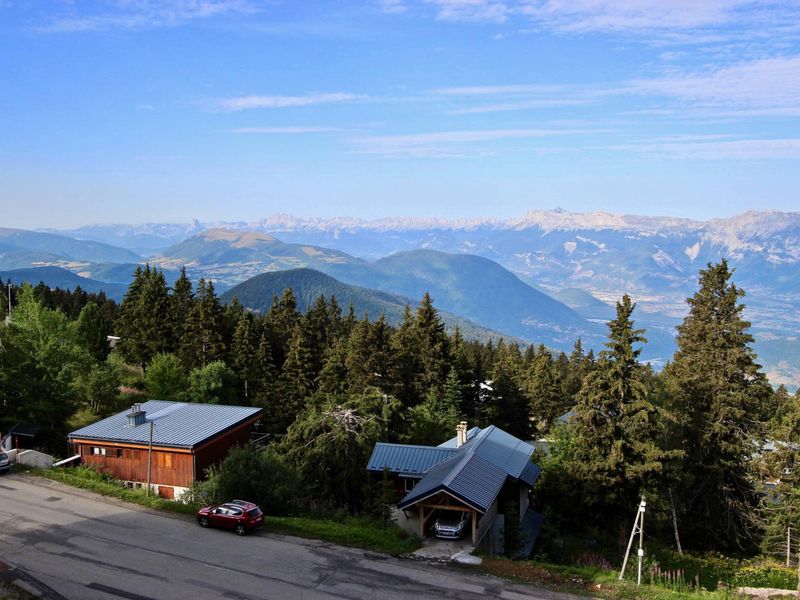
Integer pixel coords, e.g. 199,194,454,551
18,210,800,383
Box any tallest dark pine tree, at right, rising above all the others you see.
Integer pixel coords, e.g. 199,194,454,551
666,260,771,549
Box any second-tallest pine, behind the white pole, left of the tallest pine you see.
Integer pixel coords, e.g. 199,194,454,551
572,294,676,525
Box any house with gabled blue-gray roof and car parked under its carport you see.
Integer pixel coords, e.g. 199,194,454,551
367,422,542,552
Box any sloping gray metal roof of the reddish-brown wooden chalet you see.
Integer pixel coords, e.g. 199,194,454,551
68,400,263,448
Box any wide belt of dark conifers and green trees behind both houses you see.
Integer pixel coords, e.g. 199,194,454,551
0,261,800,551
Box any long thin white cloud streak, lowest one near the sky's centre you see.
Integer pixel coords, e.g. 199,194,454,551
349,129,597,158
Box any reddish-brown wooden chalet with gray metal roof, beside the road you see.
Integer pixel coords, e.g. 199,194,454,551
68,400,262,498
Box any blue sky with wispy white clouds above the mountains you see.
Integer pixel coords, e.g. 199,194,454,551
0,0,800,228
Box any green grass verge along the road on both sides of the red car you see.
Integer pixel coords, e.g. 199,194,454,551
26,467,419,556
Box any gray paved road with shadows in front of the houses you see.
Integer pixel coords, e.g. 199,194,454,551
0,474,564,600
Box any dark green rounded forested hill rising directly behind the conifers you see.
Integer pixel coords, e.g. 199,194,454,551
220,269,521,341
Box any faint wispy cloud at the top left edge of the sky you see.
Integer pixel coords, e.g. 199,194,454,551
37,0,259,33
